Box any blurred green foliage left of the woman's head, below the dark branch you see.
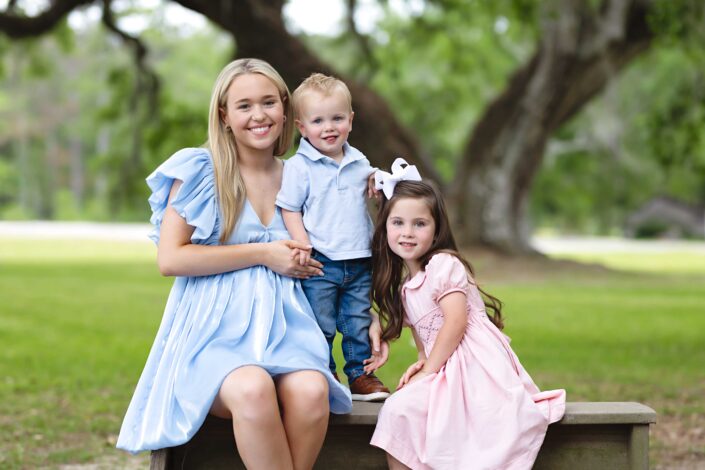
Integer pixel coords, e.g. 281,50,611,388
0,10,232,220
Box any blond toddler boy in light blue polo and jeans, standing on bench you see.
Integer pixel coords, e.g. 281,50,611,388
277,73,389,401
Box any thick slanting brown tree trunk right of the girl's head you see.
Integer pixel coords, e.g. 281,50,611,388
452,0,654,249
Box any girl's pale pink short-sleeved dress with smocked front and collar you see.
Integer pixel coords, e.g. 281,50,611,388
371,253,565,470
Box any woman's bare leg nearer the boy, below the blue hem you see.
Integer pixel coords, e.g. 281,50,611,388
277,370,330,470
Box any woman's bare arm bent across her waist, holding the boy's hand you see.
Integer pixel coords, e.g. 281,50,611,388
157,180,322,278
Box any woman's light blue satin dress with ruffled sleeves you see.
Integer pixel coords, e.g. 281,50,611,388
117,148,352,452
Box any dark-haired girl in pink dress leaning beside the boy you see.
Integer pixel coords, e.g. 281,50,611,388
371,170,565,470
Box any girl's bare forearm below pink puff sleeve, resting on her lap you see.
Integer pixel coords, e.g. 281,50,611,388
421,292,468,374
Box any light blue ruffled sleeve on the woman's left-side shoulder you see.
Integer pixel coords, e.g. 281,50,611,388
147,148,219,244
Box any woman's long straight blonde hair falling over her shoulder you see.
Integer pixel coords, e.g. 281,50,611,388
206,59,294,243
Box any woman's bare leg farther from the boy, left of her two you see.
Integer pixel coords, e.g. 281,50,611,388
210,366,293,469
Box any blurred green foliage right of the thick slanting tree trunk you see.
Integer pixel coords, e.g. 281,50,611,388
531,41,705,234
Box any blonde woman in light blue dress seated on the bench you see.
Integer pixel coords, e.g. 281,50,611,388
118,59,380,469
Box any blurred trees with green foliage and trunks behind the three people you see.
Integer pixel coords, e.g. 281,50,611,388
0,0,705,252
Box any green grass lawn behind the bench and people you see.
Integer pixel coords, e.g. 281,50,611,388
0,239,705,468
